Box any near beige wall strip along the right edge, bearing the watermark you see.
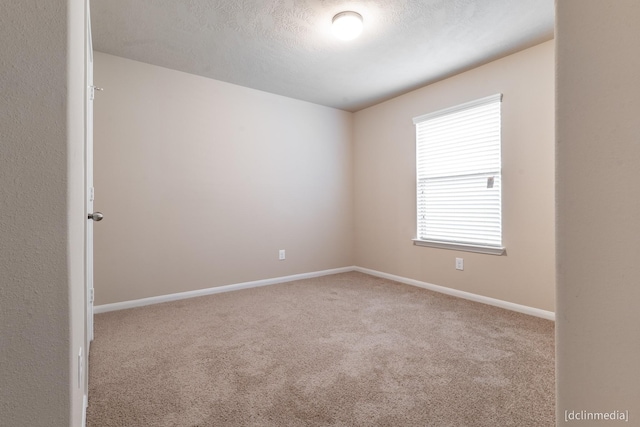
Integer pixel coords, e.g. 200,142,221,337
556,0,640,426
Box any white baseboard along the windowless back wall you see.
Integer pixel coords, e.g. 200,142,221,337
93,266,355,314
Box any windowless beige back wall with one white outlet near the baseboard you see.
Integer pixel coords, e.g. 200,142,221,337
95,53,353,304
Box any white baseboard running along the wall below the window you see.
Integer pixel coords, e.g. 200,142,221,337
354,267,556,321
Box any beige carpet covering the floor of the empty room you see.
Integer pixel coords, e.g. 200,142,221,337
87,272,555,427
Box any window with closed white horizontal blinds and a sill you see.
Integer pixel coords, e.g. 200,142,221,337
413,94,504,255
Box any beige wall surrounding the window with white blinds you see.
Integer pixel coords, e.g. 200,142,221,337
354,41,555,311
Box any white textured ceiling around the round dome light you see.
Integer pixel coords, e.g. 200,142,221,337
91,0,554,111
